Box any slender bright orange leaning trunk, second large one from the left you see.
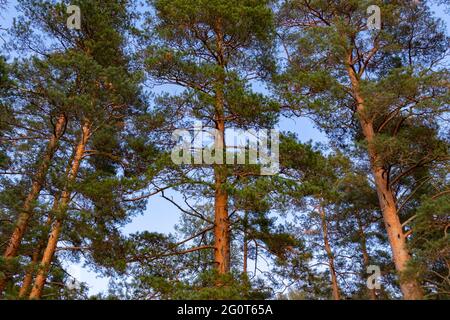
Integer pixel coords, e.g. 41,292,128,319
30,121,91,299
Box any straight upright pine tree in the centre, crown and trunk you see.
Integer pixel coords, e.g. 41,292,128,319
146,0,273,274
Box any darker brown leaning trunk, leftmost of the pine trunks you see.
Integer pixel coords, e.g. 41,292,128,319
0,114,66,296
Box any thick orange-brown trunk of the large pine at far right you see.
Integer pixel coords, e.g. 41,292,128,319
347,60,423,300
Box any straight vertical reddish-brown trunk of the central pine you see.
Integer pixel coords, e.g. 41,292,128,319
214,20,230,274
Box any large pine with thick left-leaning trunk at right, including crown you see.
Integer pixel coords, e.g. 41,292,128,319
279,1,448,299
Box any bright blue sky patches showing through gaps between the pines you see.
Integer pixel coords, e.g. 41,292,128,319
0,1,450,294
